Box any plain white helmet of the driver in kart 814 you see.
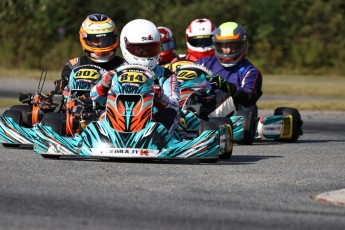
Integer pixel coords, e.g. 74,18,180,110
120,19,161,69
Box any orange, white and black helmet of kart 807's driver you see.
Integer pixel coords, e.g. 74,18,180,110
79,14,118,63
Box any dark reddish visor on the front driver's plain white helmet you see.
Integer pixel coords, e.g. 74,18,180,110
126,41,161,57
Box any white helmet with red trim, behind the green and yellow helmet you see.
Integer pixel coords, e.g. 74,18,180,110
186,18,216,52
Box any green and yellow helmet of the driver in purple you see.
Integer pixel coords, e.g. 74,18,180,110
213,22,248,67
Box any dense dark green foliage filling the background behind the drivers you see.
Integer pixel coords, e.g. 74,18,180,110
0,0,345,75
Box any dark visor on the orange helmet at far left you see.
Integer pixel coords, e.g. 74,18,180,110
84,33,117,48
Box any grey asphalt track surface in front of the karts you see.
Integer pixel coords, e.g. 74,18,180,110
0,108,345,230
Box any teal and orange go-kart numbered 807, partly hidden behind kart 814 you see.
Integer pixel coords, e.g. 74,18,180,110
0,65,104,147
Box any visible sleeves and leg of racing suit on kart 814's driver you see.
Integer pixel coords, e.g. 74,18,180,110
90,65,180,132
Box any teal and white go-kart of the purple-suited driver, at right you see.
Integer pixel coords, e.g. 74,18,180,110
175,63,303,145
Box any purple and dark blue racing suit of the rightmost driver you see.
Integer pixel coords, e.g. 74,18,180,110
196,56,262,117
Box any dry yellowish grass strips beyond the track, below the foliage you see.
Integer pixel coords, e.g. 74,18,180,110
0,68,345,111
